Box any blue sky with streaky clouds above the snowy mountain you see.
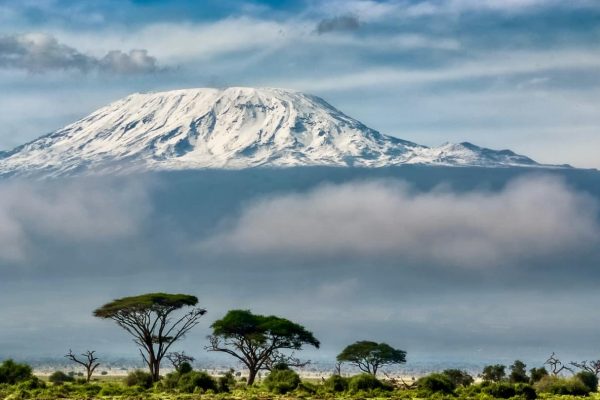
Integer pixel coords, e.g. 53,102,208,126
0,0,600,168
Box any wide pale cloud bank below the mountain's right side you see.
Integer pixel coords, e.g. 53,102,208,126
203,177,600,267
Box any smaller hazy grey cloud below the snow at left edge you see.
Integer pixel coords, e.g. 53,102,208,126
0,180,149,262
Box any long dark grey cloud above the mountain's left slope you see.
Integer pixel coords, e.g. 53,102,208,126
0,33,159,74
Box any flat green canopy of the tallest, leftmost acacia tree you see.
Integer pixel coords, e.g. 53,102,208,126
94,293,198,318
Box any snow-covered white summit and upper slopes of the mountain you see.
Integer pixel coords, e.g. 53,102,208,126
0,87,560,175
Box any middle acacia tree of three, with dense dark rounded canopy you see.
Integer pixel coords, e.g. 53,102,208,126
206,310,320,385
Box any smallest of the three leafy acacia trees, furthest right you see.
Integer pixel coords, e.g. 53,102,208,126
337,340,406,376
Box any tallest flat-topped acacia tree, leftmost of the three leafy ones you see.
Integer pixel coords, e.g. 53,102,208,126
94,293,206,382
